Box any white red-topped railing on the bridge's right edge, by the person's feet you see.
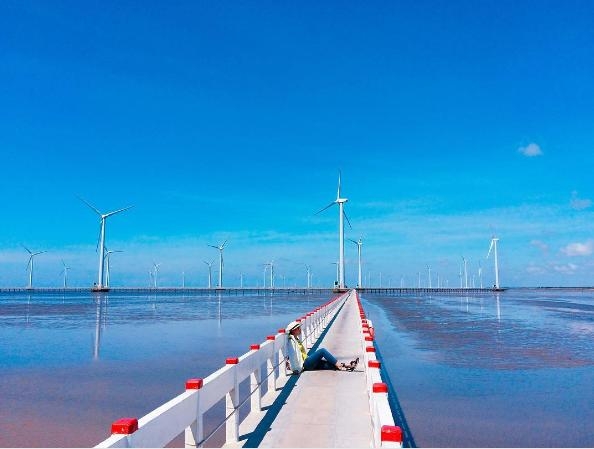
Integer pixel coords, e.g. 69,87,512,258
357,288,402,448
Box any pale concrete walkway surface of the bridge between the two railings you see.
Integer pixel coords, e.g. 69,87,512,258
228,293,372,447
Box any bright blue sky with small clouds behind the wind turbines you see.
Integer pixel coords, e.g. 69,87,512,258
0,0,594,286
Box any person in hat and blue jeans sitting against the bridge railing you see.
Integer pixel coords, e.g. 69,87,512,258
286,321,359,374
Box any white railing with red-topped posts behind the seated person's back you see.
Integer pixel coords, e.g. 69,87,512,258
95,293,350,448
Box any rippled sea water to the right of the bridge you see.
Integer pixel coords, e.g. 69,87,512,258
363,289,594,447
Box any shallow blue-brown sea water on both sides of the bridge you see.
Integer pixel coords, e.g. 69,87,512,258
0,289,594,447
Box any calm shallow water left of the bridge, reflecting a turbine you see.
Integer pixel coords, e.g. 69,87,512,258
0,293,329,447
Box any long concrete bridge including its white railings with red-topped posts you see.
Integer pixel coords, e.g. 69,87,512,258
96,290,403,448
